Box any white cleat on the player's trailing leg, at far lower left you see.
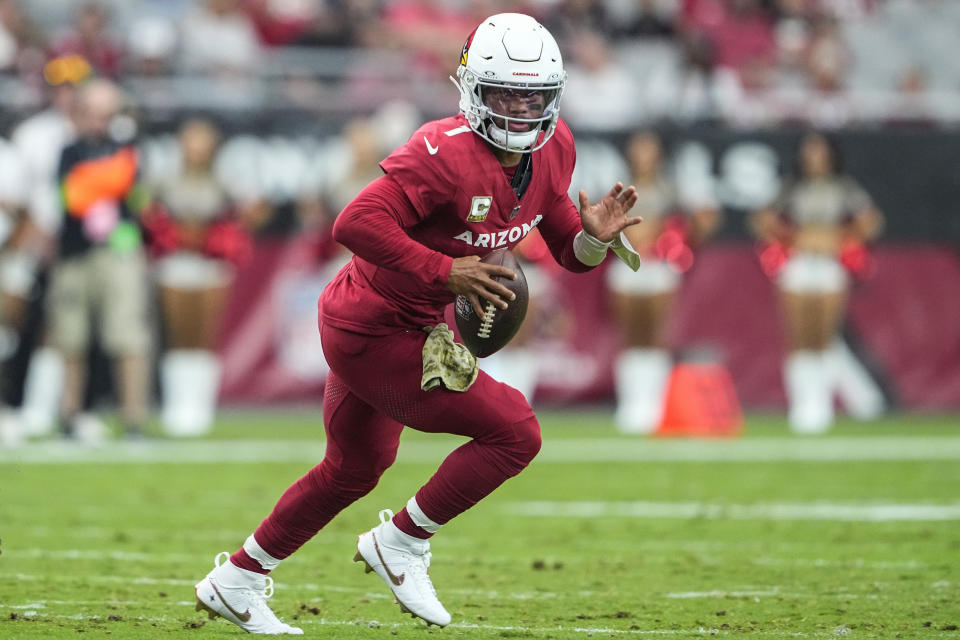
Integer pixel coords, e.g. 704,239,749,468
196,551,303,636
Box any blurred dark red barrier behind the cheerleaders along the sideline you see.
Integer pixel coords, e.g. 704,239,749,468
221,239,960,411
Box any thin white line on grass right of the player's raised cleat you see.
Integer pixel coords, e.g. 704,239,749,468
503,501,960,522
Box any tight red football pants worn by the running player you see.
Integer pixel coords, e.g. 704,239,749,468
246,325,540,559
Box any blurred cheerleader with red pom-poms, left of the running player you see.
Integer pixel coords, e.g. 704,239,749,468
143,119,250,436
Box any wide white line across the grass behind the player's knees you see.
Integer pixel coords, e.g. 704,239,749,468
0,432,960,465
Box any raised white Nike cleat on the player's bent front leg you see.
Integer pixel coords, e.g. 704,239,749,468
353,509,450,627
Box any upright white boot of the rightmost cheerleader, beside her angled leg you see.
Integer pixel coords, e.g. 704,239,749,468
783,350,833,433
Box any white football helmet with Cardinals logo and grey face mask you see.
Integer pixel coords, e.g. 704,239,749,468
451,13,567,153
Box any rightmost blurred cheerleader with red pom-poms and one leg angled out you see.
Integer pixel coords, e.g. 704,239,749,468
752,132,884,433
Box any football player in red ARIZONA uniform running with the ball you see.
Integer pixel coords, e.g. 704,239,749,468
196,13,640,634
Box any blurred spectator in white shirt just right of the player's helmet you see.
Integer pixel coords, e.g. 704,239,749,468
560,31,643,132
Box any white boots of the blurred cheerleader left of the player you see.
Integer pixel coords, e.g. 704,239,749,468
160,349,220,436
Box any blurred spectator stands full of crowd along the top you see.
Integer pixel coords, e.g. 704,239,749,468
0,0,960,130
